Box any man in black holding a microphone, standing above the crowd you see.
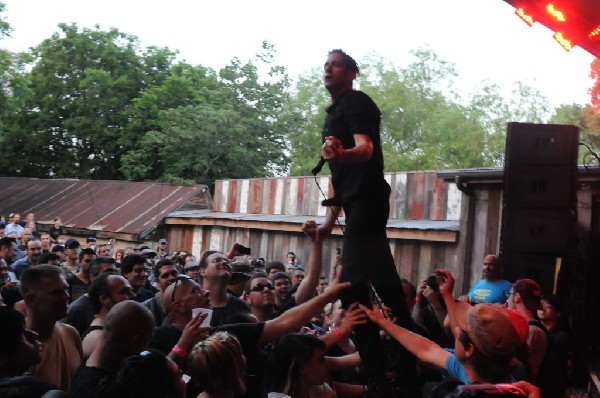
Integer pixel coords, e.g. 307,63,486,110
308,50,414,394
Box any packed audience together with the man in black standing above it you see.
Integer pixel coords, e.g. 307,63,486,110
0,50,572,398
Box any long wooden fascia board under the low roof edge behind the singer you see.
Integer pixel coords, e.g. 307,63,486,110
165,217,458,243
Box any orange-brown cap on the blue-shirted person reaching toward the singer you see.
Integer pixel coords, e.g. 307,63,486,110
451,302,520,359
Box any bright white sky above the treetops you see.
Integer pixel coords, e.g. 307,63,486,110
0,0,594,106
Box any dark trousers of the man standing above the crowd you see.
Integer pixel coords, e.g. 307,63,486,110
340,188,416,392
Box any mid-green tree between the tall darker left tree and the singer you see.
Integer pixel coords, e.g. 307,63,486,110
122,43,289,185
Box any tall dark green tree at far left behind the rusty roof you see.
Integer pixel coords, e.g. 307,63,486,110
1,24,175,179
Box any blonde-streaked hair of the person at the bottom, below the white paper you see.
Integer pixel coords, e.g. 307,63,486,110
188,332,246,394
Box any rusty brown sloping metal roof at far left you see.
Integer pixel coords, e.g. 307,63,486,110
0,177,211,237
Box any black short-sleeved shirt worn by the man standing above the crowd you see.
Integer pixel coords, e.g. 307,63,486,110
322,90,386,204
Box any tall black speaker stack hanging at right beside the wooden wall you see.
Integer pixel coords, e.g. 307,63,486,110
500,123,579,292
